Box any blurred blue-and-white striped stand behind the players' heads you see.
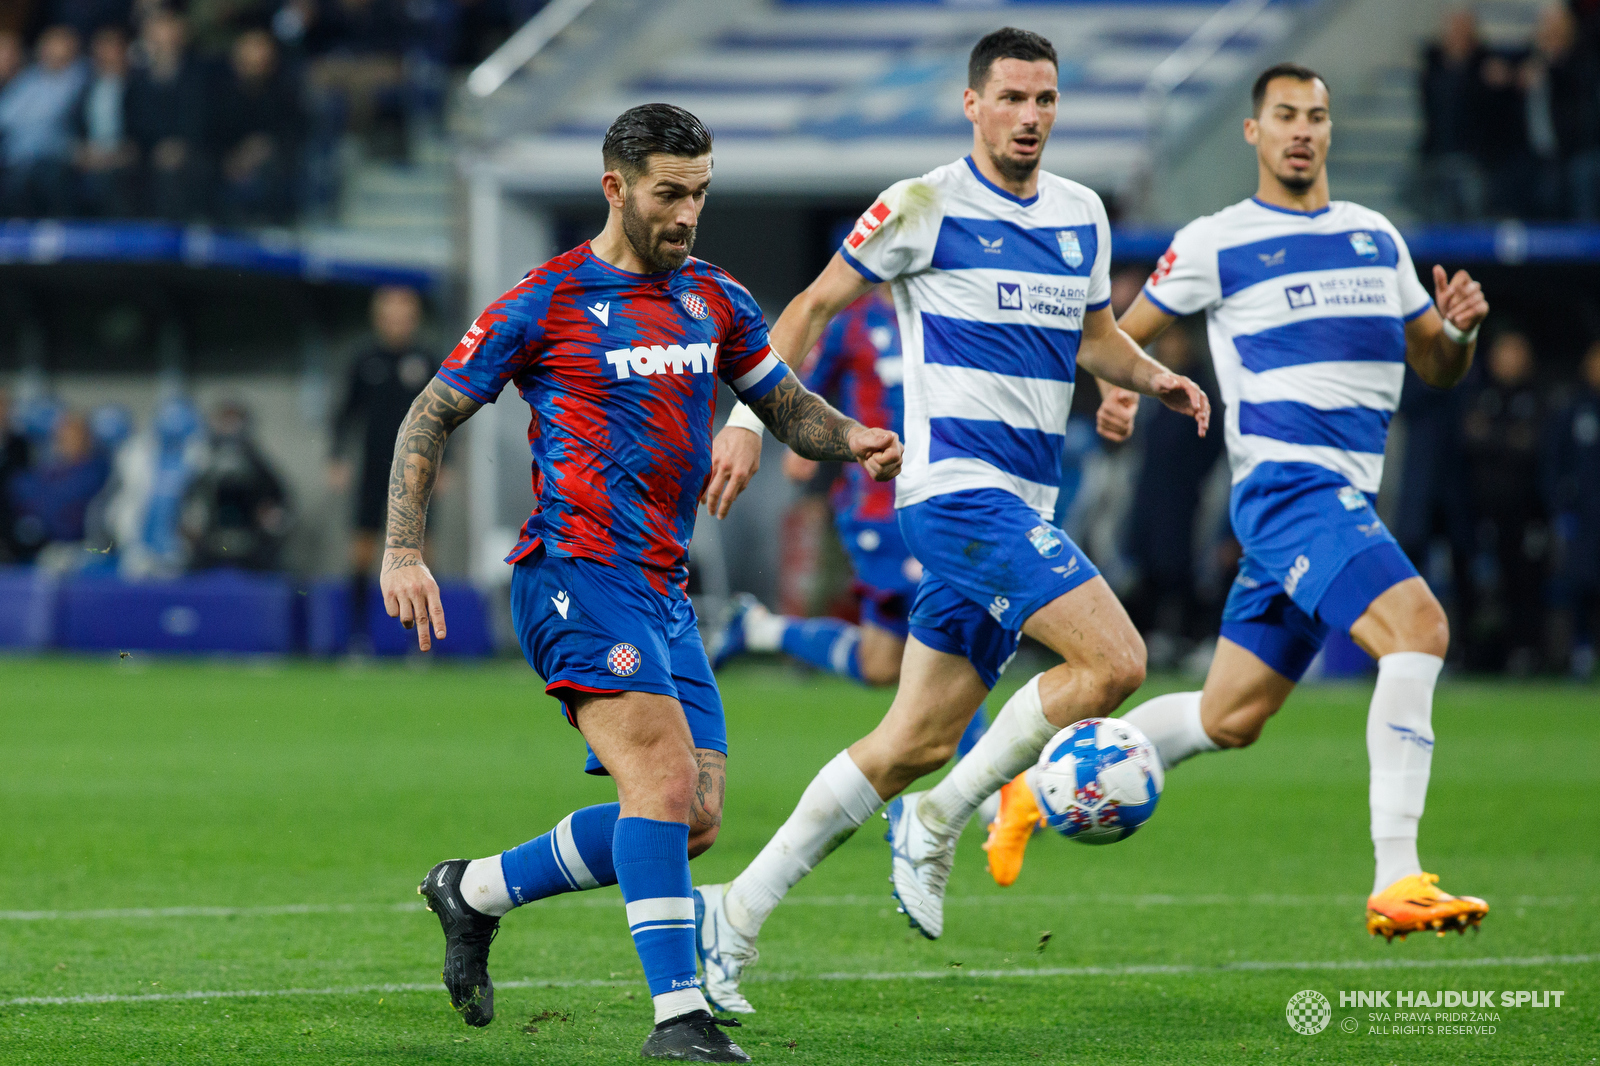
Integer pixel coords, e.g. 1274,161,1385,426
474,0,1315,195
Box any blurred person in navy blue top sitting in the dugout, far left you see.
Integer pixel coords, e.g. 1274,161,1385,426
10,404,110,562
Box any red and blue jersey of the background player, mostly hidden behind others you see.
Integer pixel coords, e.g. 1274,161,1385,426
800,288,906,522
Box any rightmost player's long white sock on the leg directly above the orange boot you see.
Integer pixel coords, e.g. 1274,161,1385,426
1366,651,1445,893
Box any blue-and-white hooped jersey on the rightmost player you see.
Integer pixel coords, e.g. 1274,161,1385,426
1144,198,1432,493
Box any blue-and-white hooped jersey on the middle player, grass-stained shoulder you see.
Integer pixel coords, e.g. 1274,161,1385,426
840,157,1110,519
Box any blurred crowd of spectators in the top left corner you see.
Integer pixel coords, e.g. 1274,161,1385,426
0,0,546,224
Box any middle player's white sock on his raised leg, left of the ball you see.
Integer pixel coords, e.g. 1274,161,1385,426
917,674,1061,837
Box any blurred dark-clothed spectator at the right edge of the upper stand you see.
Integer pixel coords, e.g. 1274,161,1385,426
1522,5,1600,219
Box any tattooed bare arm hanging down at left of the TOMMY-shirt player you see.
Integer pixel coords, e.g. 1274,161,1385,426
379,378,483,651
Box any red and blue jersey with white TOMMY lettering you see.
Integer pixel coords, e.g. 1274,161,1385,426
438,242,789,599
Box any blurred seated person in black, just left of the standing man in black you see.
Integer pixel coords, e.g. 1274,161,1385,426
182,402,290,570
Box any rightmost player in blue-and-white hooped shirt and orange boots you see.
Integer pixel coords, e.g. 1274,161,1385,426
1081,64,1488,938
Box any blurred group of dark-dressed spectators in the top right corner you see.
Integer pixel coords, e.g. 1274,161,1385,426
1413,0,1600,222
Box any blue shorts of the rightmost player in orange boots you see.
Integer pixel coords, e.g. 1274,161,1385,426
1221,463,1418,682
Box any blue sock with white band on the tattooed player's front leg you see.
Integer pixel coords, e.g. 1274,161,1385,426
613,818,706,1023
